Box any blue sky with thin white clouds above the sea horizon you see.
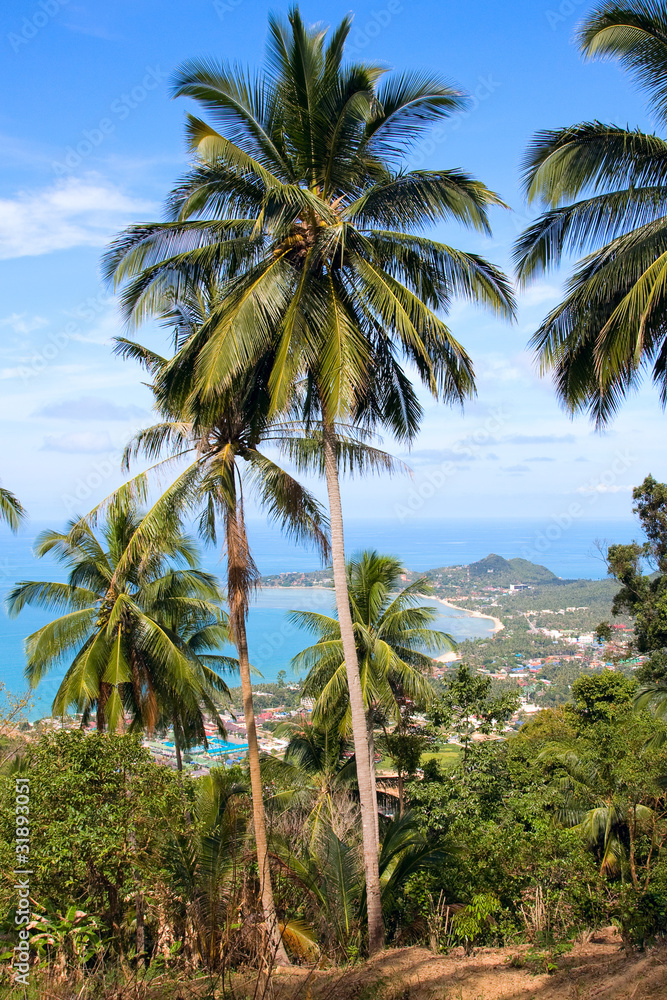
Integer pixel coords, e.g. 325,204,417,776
0,0,667,524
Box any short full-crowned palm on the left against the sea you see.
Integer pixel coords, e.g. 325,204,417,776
7,502,235,742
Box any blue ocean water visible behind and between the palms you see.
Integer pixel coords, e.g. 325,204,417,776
0,519,638,718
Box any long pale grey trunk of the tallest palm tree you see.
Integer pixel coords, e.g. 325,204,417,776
323,421,384,955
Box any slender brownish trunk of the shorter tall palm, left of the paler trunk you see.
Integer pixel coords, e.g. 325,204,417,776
227,504,290,965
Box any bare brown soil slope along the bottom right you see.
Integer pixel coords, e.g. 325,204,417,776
272,927,667,1000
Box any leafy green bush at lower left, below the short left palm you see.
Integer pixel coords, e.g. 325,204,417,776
0,730,183,951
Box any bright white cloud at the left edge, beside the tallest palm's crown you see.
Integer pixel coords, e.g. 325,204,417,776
0,174,156,259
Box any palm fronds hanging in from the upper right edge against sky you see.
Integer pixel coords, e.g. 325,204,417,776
515,0,667,425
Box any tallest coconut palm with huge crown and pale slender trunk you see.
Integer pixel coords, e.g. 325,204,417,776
106,8,513,952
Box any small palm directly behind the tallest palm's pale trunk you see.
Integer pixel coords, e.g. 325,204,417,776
290,551,454,840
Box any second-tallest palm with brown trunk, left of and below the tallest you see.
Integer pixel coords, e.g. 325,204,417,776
98,306,332,963
